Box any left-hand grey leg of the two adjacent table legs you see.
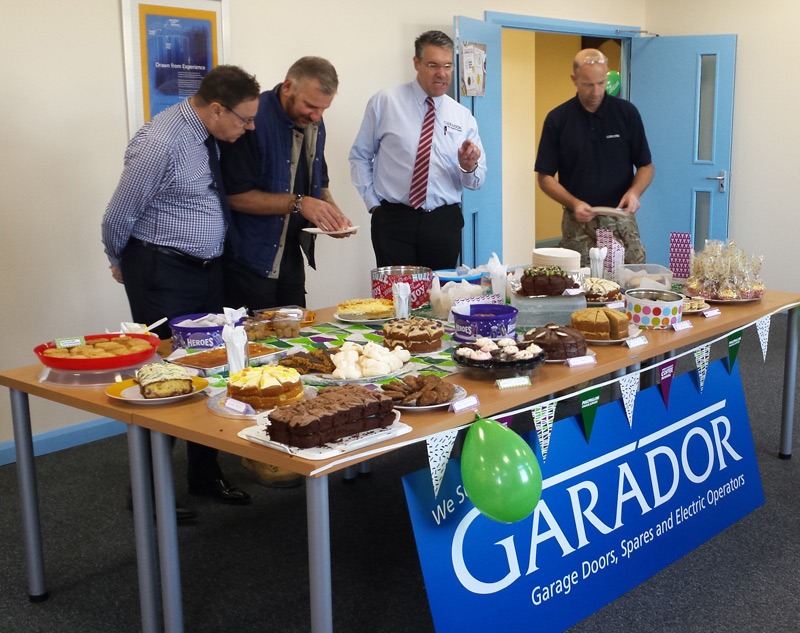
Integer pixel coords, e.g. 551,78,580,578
128,424,163,633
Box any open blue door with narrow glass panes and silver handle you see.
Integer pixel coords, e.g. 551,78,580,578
630,35,736,265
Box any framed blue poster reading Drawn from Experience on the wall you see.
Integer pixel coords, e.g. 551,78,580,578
121,0,228,136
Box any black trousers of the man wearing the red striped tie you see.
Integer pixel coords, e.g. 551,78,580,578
371,201,464,270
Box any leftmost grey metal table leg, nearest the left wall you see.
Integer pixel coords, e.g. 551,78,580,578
10,389,48,602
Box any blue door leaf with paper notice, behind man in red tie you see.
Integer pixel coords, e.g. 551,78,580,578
453,16,503,268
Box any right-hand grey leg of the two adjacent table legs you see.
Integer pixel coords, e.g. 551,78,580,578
150,431,183,633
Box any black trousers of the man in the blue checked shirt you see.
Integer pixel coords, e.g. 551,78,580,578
121,242,224,487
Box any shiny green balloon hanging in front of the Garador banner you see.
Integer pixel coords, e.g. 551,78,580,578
461,418,542,523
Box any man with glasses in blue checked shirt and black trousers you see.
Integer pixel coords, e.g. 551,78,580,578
102,66,260,520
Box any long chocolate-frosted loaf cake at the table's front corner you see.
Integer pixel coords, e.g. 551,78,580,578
268,385,395,448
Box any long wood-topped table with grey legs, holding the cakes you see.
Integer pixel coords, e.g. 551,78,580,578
0,291,800,633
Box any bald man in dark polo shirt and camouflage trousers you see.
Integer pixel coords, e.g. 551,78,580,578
535,48,655,266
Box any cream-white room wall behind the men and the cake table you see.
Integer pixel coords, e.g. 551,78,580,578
17,0,788,441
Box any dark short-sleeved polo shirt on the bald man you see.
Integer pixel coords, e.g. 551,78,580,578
535,95,652,207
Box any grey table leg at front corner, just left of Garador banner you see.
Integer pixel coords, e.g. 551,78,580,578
306,475,333,633
